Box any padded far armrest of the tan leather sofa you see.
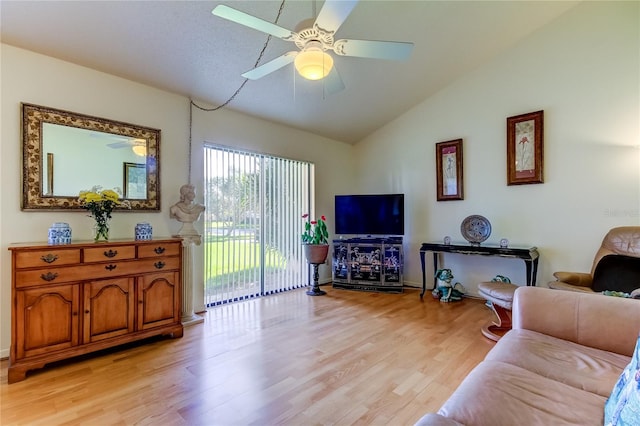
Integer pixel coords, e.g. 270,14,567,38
512,287,640,356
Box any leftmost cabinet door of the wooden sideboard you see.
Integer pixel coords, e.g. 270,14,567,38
14,284,80,359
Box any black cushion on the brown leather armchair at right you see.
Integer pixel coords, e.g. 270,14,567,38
591,254,640,293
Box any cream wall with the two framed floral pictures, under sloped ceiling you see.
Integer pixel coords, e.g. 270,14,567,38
354,2,640,294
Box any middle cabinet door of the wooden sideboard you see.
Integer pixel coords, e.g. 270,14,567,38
83,277,135,343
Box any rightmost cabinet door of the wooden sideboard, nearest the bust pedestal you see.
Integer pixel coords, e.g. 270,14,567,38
138,272,180,330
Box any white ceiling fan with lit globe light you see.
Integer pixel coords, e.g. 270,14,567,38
211,0,413,93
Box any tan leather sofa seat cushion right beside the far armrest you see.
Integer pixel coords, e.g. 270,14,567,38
486,330,630,398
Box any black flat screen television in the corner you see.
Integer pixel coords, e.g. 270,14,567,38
335,194,404,236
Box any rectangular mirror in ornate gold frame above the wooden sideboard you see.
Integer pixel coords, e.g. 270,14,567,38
22,103,160,211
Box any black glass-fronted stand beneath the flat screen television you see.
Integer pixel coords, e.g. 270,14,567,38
332,236,403,293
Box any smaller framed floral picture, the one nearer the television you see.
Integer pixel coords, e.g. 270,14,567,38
436,139,464,201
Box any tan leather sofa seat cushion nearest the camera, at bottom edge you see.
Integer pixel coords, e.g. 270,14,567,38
438,361,606,426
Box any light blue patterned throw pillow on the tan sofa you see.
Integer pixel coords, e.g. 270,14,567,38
604,336,640,425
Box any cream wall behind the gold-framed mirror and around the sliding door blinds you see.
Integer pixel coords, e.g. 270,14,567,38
0,44,352,357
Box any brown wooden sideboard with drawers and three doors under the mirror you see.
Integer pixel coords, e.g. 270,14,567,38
8,238,183,383
